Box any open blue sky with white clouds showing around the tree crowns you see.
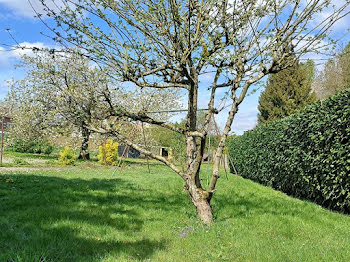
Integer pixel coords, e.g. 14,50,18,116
0,0,350,134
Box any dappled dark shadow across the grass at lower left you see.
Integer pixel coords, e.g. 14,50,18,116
0,174,183,261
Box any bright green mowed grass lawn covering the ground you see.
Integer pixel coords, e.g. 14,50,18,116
0,163,350,262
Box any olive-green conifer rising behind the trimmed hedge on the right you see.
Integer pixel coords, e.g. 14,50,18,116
258,61,316,123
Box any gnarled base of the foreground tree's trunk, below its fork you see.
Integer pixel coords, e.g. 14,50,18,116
187,178,213,225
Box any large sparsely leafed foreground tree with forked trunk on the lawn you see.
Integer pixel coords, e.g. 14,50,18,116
33,0,349,223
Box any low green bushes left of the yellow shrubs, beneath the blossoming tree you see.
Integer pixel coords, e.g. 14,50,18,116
9,139,54,155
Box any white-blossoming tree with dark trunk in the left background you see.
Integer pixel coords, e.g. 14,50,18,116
8,50,108,159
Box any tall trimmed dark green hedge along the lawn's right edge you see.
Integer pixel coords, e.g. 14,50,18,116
228,89,350,213
